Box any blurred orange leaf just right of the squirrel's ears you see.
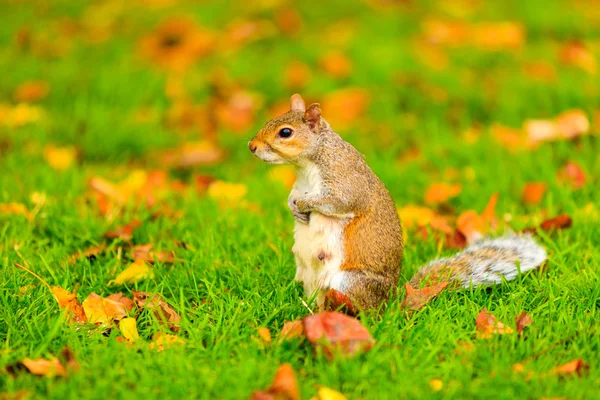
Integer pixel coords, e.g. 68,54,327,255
321,87,371,130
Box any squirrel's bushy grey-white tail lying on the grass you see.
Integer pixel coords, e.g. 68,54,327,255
409,235,546,288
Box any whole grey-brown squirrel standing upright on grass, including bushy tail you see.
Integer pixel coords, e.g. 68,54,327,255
248,94,546,310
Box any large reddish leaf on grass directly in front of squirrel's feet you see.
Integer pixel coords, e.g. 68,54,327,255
302,311,375,358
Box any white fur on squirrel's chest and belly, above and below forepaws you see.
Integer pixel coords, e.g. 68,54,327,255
292,162,350,304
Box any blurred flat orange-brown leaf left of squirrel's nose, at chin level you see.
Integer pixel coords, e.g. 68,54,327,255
160,141,225,168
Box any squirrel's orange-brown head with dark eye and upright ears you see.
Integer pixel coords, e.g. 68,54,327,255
248,94,324,164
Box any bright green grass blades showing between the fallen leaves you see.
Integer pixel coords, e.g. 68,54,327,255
0,1,600,399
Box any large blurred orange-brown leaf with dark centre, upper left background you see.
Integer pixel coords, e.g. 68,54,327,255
139,18,215,72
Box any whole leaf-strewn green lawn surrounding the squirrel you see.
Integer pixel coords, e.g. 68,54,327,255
0,0,600,400
